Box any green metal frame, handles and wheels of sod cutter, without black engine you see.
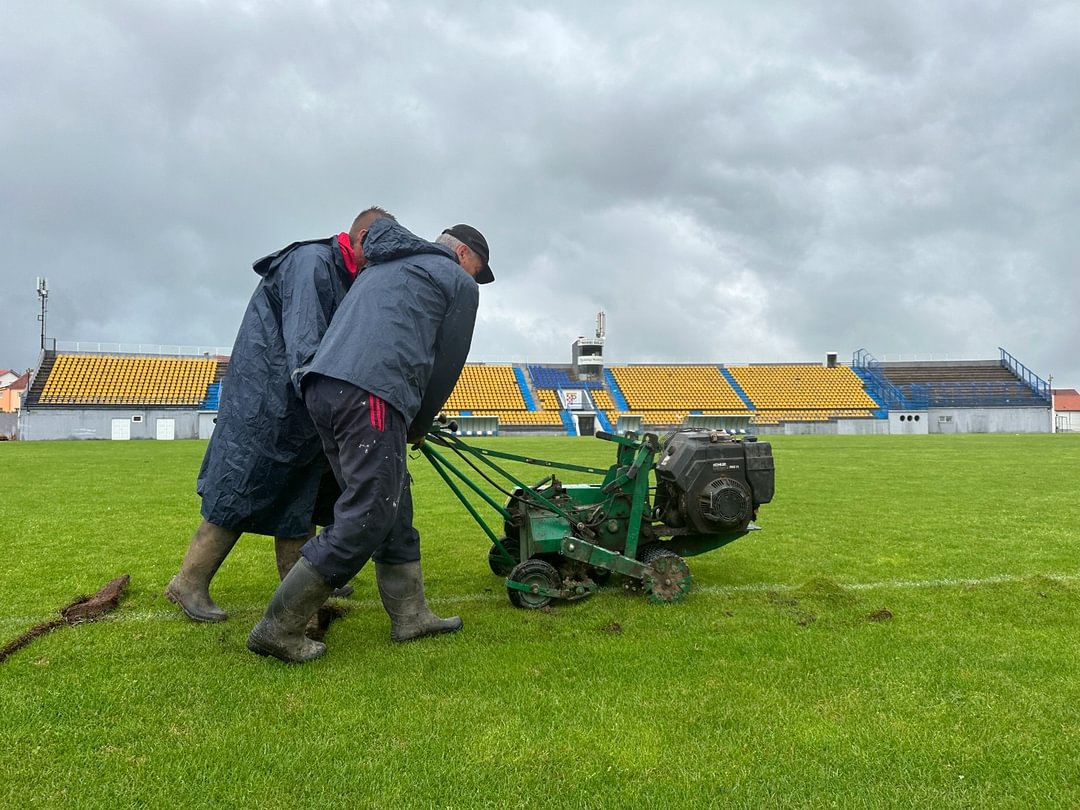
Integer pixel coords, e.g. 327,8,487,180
420,421,759,608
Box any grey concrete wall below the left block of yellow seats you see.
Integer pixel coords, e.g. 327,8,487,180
18,408,199,441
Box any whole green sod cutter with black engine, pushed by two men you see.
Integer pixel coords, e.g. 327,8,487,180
420,417,773,609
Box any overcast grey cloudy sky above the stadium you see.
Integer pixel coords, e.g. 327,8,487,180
0,0,1080,387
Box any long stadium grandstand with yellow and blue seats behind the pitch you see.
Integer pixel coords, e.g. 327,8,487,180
8,335,1054,438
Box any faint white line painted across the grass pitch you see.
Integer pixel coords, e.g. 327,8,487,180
0,573,1080,630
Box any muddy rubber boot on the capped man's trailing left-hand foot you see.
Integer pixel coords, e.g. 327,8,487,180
247,557,334,663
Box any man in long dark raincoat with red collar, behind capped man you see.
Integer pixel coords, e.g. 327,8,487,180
165,207,393,622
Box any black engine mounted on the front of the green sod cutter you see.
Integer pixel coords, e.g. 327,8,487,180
653,431,774,535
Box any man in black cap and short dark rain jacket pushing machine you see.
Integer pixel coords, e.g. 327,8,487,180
247,219,495,661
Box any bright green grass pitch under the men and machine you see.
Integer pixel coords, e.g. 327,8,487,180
0,435,1080,808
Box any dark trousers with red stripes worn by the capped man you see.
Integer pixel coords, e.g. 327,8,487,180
300,375,420,588
